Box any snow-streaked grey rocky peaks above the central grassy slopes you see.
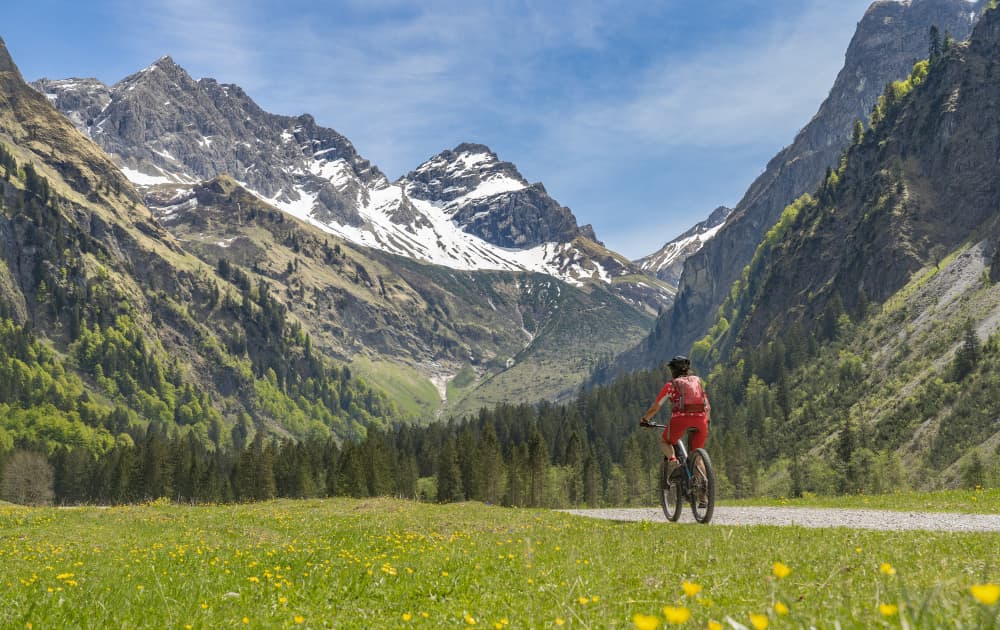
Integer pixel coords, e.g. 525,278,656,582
35,65,673,304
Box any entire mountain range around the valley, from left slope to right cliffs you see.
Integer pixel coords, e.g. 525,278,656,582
0,0,1000,496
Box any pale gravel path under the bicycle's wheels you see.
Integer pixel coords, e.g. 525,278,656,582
563,507,1000,532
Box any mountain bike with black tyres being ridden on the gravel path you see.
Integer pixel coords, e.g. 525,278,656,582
643,422,715,524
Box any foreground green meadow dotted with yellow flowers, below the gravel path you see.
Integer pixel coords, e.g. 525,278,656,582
0,499,1000,630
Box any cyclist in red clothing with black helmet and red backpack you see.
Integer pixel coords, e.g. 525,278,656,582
639,356,712,482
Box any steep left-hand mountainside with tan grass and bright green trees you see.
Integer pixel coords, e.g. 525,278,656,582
0,37,397,453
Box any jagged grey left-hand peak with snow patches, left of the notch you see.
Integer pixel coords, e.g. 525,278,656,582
35,57,388,230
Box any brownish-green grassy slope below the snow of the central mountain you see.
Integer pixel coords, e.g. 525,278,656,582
147,176,650,418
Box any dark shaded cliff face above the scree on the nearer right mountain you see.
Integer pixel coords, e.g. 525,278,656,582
733,2,1000,348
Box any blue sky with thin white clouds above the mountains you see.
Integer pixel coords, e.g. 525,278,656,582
0,0,869,258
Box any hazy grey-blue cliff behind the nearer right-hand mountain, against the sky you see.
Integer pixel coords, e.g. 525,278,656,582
620,0,983,369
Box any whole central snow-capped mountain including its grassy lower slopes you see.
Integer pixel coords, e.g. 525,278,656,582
25,50,688,417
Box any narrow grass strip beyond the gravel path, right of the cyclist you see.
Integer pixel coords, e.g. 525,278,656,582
720,488,1000,514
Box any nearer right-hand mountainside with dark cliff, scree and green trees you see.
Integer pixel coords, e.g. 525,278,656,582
693,9,1000,493
